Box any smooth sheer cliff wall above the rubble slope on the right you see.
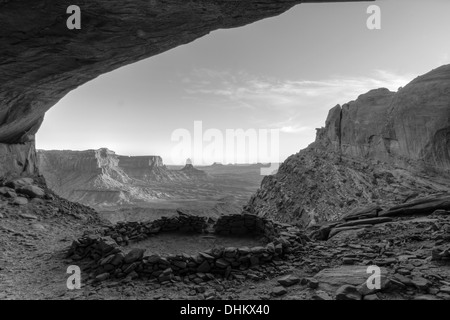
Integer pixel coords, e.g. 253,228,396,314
317,65,450,171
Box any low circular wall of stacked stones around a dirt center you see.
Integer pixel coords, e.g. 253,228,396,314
68,214,308,284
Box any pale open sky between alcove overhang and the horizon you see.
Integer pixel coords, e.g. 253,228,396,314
36,0,450,165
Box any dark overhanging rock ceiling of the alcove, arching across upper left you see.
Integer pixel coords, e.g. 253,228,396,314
0,0,362,175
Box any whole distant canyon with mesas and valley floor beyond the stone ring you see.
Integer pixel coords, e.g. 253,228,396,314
38,148,262,221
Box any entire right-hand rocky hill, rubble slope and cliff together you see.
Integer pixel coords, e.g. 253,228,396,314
245,65,450,226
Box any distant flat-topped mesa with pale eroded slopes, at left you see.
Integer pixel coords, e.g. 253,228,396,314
38,148,207,206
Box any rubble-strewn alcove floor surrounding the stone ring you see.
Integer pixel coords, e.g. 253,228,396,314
0,198,450,300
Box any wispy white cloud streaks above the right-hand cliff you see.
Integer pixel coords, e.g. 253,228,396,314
179,68,414,133
